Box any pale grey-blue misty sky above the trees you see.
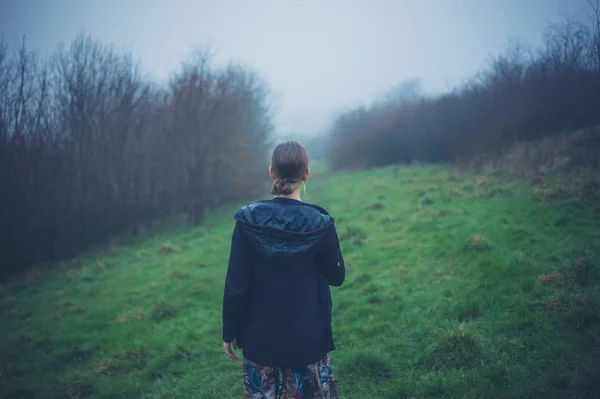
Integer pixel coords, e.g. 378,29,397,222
0,0,588,134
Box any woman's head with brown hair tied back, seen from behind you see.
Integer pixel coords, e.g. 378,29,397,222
269,141,310,195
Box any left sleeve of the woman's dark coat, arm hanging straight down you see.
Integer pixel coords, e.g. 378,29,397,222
223,222,252,342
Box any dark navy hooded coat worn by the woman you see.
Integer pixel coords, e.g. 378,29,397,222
223,197,345,367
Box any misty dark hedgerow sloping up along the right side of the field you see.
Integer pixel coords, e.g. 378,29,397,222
328,9,600,168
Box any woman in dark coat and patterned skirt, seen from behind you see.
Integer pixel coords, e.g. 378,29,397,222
223,142,346,399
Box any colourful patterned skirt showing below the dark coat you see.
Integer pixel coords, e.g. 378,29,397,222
243,356,339,399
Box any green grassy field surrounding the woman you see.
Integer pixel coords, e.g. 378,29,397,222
0,166,600,399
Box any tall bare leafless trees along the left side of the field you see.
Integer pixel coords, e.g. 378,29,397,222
0,34,272,276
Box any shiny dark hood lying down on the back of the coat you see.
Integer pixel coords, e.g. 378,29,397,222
235,197,334,257
